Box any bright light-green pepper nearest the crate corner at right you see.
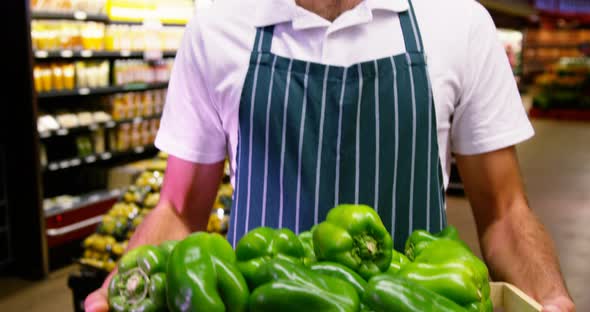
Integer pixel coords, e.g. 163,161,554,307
398,260,484,305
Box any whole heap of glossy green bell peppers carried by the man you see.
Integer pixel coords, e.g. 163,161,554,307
109,205,493,312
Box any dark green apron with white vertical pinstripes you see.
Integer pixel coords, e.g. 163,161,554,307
227,3,446,250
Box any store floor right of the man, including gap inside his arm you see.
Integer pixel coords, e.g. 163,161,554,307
448,120,590,311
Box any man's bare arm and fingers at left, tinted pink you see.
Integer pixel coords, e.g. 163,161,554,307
84,156,224,312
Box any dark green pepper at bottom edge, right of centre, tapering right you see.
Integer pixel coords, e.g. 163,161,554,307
363,274,465,312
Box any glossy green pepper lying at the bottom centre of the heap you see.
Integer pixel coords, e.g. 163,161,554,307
249,259,360,312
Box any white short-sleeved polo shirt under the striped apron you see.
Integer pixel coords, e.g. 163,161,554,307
156,0,534,186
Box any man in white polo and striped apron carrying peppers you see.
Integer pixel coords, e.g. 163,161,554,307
86,0,574,312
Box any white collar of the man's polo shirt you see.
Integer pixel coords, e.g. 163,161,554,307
254,0,409,30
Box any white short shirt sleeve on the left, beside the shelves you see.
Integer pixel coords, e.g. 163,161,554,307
155,15,227,164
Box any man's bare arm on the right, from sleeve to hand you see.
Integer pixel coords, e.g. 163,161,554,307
456,147,575,312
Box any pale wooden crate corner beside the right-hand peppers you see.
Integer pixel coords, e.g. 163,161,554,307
491,282,542,312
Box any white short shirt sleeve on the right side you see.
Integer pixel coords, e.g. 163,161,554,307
451,3,534,155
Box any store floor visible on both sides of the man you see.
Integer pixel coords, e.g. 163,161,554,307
0,121,590,312
